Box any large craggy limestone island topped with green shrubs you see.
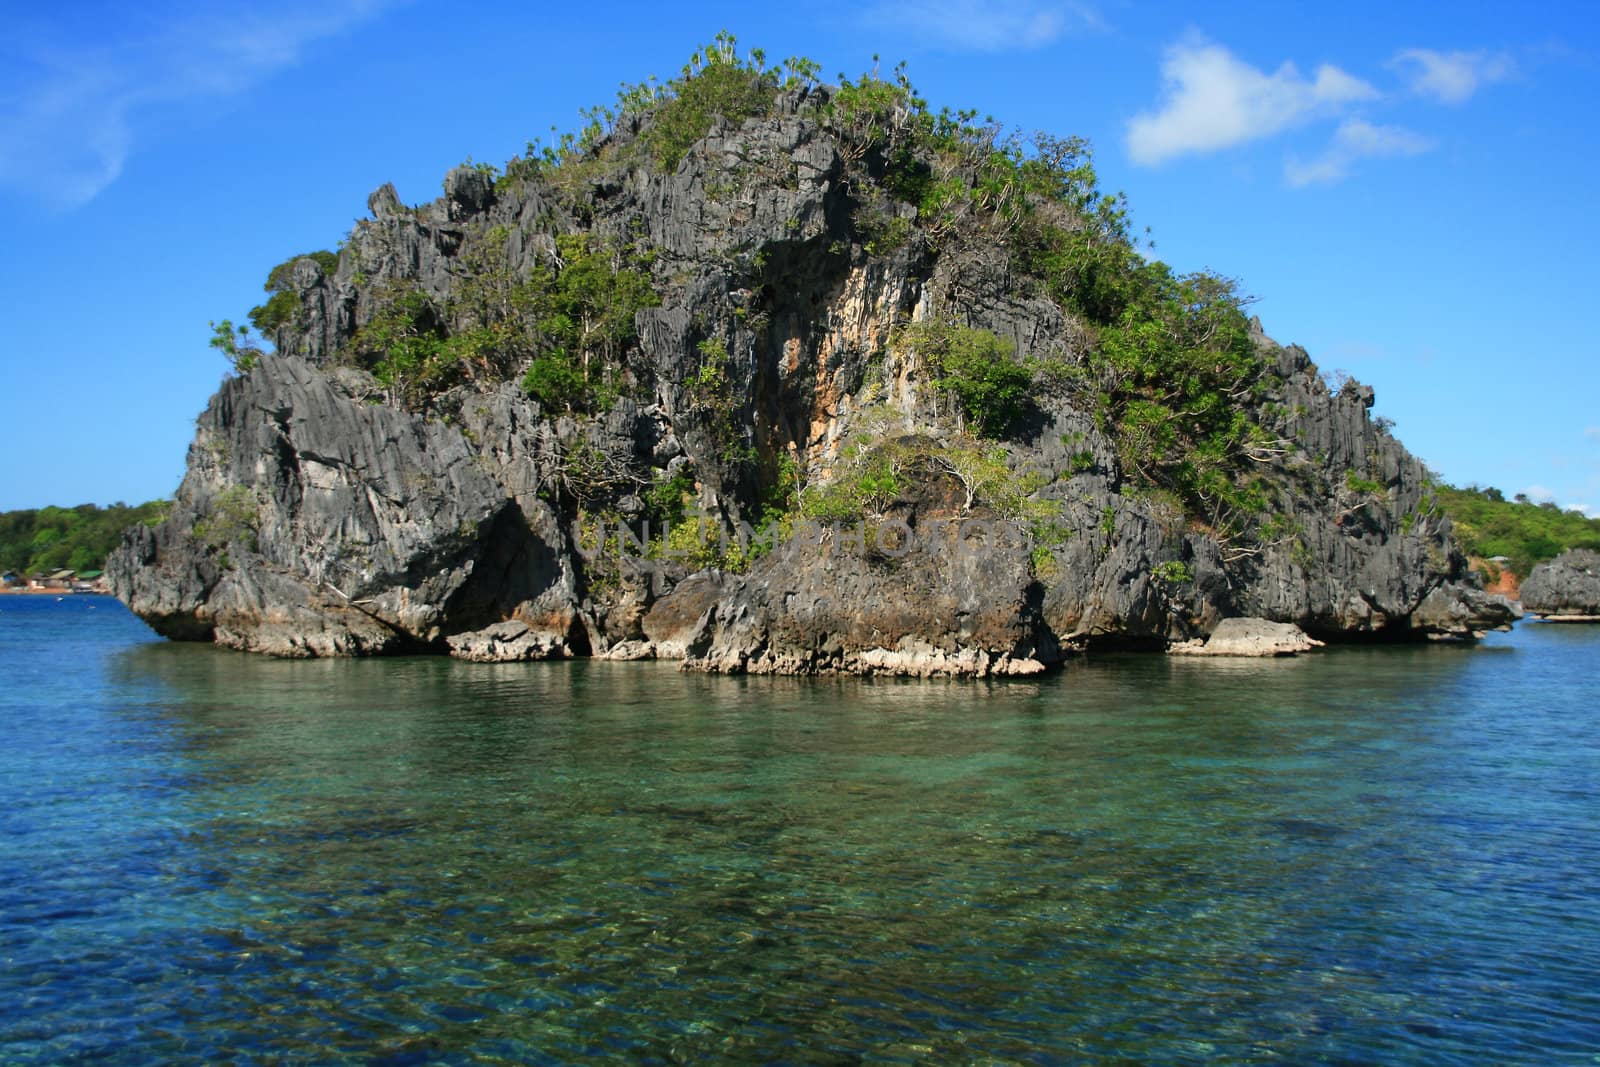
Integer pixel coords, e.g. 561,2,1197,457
107,37,1514,675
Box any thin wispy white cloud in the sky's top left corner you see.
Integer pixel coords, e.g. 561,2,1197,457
0,0,389,208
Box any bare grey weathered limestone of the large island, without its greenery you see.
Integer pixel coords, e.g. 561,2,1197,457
107,81,1510,675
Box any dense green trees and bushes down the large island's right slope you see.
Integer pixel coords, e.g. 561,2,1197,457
790,69,1274,539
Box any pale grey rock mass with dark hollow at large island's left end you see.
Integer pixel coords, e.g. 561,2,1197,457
107,357,587,656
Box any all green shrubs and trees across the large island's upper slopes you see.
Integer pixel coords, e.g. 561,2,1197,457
219,34,1350,563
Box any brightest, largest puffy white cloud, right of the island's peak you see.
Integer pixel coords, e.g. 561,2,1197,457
1128,38,1378,165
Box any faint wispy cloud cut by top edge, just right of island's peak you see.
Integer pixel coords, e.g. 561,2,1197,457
862,0,1104,51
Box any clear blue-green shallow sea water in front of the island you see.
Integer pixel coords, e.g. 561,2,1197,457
0,597,1600,1064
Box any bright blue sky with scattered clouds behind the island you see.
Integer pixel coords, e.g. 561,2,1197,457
0,0,1600,514
